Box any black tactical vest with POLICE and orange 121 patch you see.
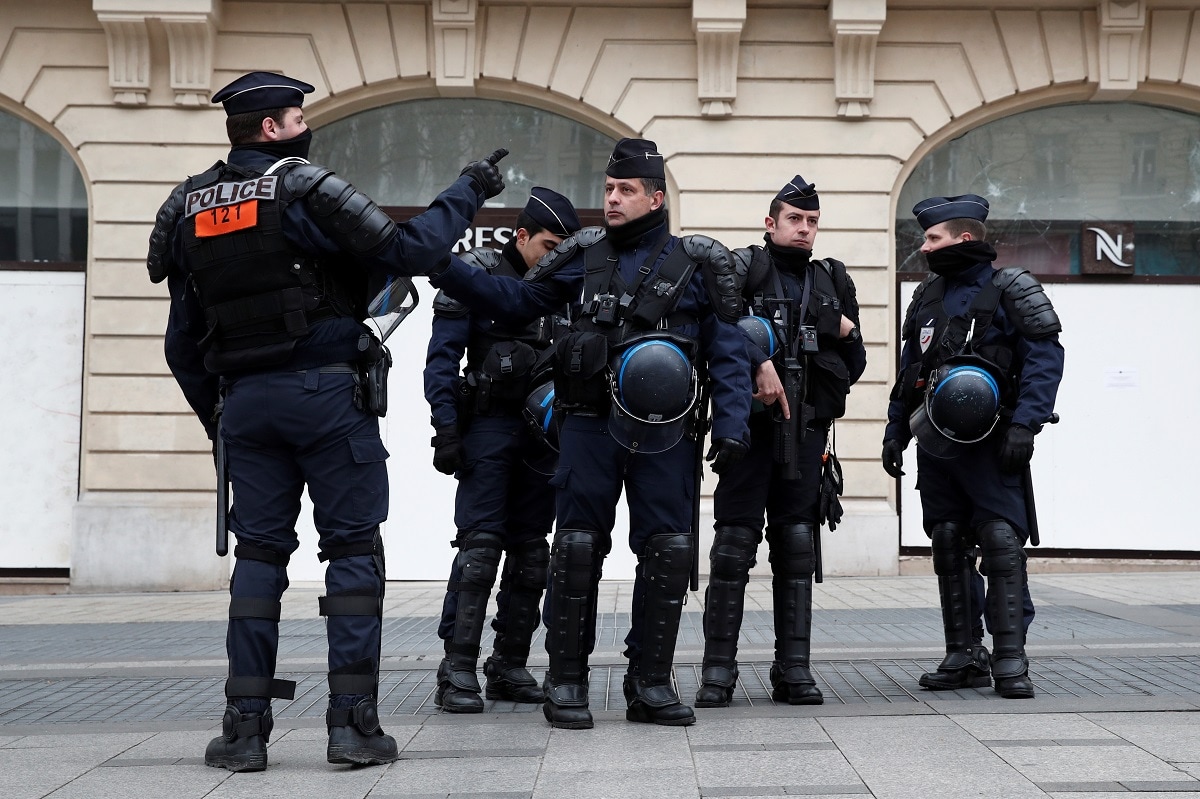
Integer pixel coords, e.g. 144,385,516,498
181,162,366,373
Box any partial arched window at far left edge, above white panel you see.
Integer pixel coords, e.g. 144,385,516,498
0,112,88,270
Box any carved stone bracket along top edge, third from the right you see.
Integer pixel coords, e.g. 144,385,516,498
691,0,746,116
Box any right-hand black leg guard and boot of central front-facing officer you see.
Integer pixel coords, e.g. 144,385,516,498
624,534,696,727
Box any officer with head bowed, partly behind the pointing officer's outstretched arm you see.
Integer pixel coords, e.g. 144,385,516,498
425,186,580,713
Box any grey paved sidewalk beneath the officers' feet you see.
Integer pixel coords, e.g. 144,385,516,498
0,572,1200,799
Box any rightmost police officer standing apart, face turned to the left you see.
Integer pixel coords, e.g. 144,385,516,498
882,194,1063,698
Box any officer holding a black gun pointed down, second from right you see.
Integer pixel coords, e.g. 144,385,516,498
696,175,866,708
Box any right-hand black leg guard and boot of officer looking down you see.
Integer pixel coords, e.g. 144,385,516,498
484,539,550,704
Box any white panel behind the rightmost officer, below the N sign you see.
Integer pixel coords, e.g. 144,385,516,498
900,283,1200,552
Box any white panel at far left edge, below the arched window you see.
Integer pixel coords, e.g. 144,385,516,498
0,271,84,569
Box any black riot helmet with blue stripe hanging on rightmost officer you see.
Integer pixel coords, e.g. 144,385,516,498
908,355,1002,458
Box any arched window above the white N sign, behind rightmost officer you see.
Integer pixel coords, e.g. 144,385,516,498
896,103,1200,278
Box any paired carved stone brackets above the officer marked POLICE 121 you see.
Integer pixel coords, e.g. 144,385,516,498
91,0,221,108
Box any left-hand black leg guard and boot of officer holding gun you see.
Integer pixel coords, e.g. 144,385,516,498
696,527,762,708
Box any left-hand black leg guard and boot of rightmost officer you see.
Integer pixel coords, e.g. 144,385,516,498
919,522,991,691
